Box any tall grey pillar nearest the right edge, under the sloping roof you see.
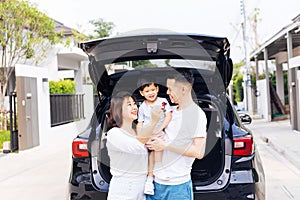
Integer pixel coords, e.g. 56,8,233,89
287,32,299,130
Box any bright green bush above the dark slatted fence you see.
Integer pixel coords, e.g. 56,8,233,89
49,80,75,94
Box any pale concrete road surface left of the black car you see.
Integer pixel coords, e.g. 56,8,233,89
0,122,78,200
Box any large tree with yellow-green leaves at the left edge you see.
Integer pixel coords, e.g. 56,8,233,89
0,0,62,111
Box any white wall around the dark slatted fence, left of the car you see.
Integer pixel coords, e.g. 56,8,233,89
15,65,94,148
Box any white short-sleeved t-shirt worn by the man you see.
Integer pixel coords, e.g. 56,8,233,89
154,103,207,185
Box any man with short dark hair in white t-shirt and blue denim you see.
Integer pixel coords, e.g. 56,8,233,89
146,69,207,200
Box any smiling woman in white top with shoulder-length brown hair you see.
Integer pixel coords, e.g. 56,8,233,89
107,92,162,200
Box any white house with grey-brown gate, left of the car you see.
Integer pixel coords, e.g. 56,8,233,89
8,21,94,150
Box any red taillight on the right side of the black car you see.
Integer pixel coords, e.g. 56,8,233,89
233,136,254,156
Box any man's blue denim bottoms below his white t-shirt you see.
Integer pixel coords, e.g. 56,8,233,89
146,180,193,200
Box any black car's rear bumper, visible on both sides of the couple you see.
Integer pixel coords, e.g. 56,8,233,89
67,159,265,200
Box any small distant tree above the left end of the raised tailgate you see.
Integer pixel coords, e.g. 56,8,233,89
88,18,115,39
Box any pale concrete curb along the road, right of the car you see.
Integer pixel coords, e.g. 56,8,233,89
260,136,300,169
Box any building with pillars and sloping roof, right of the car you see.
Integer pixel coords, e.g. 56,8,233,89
250,15,300,130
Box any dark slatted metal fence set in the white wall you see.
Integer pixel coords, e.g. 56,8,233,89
50,94,84,127
